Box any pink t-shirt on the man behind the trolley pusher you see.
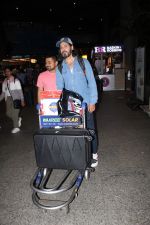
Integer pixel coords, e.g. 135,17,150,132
37,70,57,91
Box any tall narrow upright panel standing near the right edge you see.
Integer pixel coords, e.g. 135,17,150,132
135,47,145,101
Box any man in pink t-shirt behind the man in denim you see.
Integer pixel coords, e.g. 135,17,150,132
37,56,57,103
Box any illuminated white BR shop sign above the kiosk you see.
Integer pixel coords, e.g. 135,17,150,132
94,45,122,53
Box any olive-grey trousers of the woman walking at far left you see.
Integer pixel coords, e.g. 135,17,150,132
6,97,20,128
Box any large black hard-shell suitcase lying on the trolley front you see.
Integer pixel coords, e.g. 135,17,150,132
33,128,92,170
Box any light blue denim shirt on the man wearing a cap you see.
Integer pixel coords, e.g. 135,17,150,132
56,57,98,104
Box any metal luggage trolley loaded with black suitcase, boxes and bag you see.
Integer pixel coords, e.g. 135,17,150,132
30,90,94,213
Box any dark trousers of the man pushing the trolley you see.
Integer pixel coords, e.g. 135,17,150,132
86,110,97,154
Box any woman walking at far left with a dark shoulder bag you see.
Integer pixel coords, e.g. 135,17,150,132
0,67,25,134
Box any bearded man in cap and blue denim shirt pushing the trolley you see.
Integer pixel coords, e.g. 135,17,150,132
56,37,98,167
